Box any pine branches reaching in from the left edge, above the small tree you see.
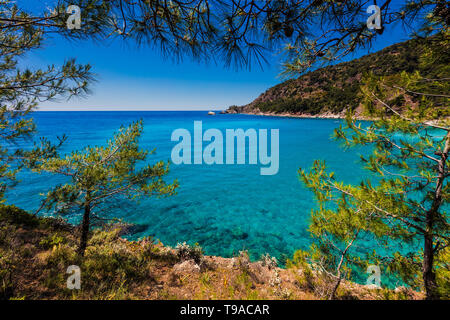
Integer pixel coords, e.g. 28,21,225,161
0,0,92,202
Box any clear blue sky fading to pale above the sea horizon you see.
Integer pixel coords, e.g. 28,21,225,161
21,0,416,111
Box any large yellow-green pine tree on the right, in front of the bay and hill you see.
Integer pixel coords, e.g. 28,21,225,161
299,33,450,298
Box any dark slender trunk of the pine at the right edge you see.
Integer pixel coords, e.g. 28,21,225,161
422,132,450,300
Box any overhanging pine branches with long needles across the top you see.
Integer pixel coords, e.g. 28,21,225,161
1,0,448,77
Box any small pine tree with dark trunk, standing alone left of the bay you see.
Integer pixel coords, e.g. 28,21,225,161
34,121,178,255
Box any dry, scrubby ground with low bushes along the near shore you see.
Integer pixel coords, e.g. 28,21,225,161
0,205,424,300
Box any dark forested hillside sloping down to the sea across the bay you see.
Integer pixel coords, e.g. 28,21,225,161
227,40,438,116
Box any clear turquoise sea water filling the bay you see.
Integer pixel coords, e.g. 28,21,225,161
8,112,367,258
